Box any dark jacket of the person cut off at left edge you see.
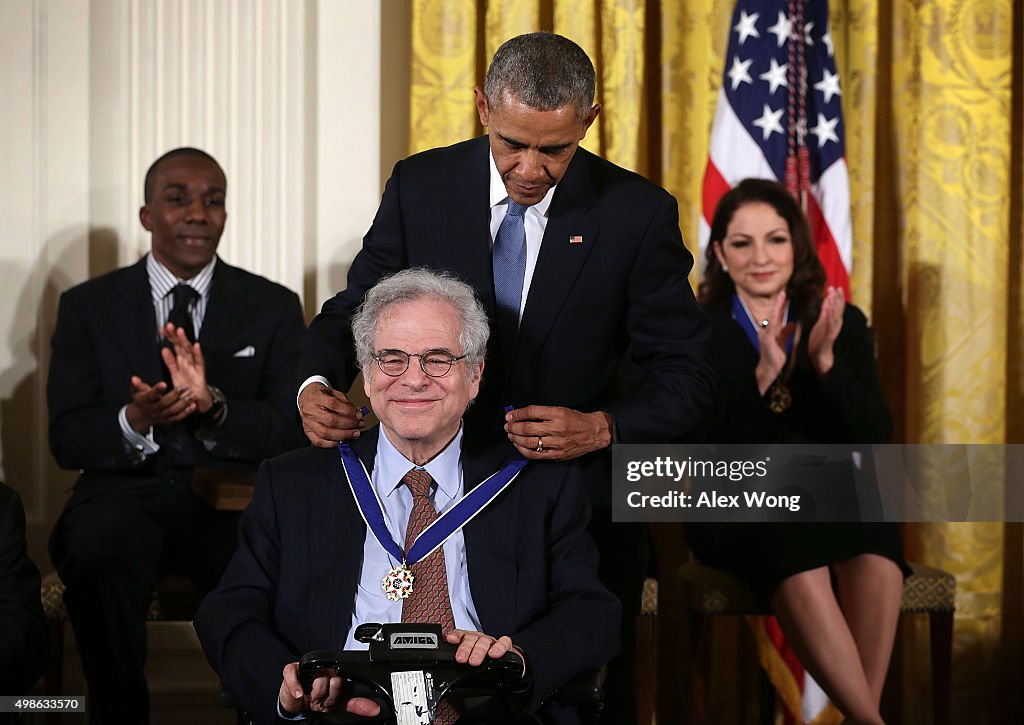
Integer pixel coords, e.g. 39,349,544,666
0,483,48,695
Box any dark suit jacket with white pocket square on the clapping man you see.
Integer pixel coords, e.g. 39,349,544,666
47,258,304,486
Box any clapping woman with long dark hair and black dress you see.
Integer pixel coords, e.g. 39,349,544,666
686,179,908,724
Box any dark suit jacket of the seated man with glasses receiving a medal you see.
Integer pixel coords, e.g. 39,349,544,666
196,429,620,722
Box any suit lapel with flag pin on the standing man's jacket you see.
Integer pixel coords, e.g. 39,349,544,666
514,148,599,370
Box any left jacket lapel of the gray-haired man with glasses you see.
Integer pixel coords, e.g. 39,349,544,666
307,429,377,649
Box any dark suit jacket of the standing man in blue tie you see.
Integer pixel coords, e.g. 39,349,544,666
299,137,714,506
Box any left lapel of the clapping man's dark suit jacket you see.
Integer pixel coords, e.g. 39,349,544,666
110,257,164,385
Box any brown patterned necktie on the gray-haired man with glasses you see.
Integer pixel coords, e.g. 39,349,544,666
401,468,459,725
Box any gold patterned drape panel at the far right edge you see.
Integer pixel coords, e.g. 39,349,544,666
874,0,1024,722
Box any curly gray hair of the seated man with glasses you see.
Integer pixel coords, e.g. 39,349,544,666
352,267,490,379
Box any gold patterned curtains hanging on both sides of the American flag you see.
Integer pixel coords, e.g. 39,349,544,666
410,0,1024,723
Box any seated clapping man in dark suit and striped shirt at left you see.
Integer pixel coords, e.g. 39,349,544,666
47,147,304,723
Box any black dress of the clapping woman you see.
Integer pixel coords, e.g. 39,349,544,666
685,300,909,600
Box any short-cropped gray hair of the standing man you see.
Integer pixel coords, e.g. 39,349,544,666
483,33,595,121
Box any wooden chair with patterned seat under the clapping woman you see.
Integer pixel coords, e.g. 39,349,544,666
641,524,956,725
